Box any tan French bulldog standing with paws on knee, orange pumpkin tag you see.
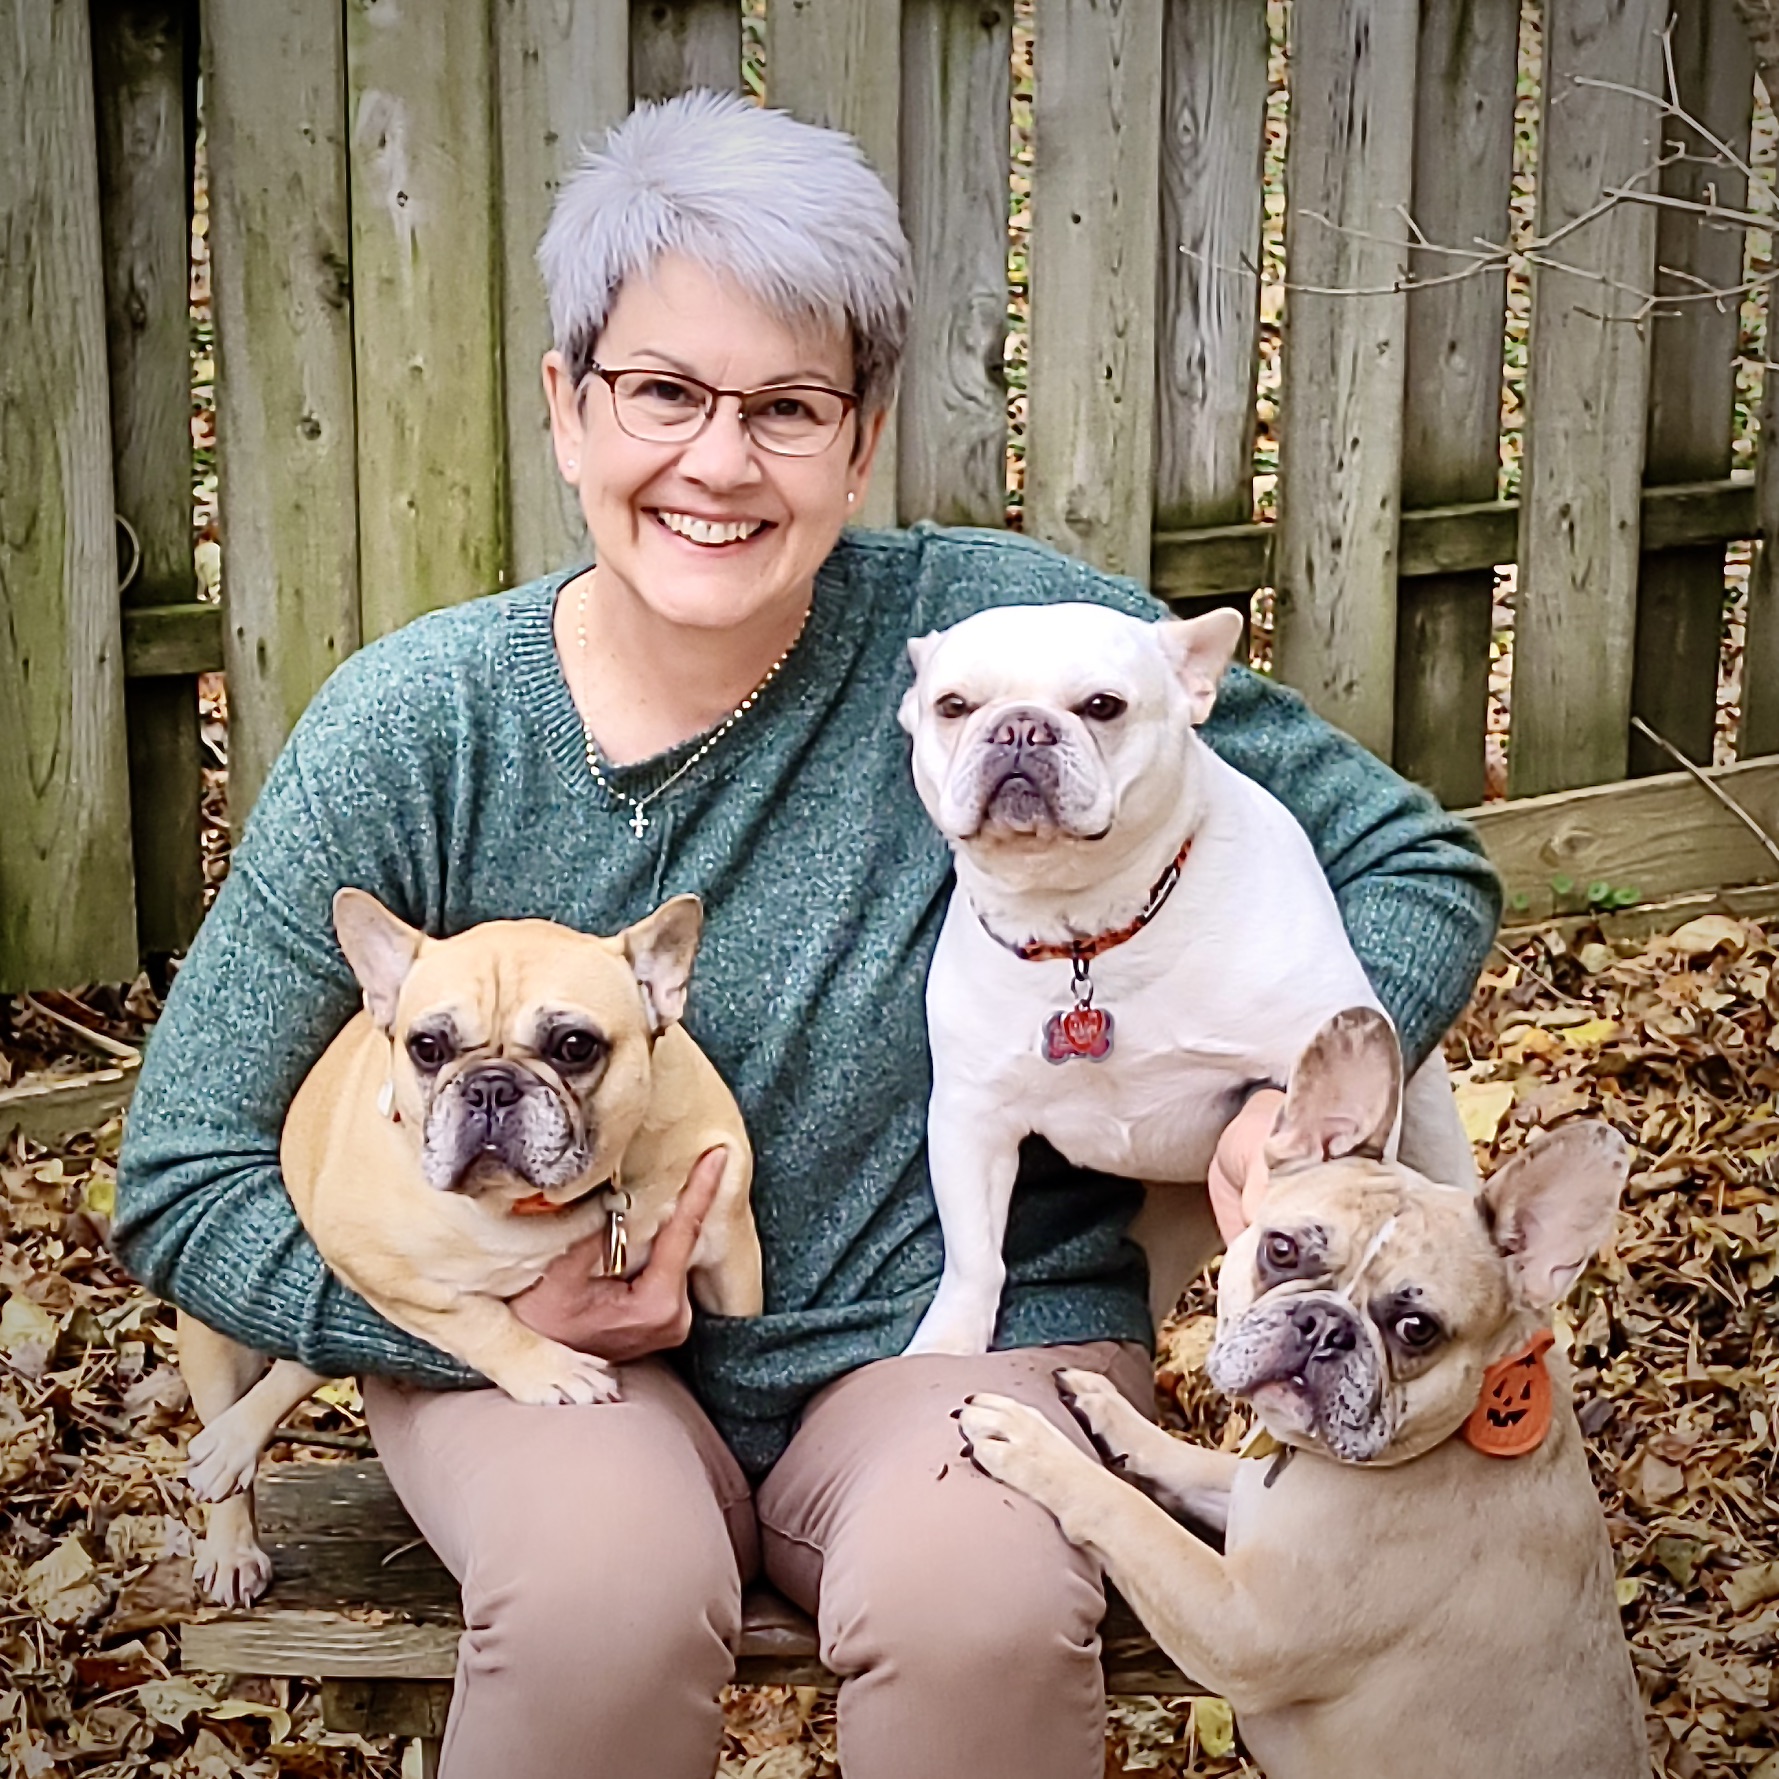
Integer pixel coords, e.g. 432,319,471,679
961,1009,1649,1779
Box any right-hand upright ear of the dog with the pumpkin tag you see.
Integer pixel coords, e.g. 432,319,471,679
1478,1124,1631,1309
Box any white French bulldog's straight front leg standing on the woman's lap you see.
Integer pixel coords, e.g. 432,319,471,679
906,1085,1023,1354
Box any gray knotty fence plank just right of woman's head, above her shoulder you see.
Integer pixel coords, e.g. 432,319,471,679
897,0,1012,525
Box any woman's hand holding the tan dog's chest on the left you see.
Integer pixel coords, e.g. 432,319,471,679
512,1149,726,1364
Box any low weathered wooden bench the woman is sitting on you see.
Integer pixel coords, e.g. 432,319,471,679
181,1459,1199,1774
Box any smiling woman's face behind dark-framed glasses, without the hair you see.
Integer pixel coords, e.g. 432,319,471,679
544,256,882,630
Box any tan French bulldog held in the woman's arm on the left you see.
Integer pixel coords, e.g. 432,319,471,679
180,890,763,1605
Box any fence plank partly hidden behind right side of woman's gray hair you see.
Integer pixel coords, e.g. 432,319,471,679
767,0,902,525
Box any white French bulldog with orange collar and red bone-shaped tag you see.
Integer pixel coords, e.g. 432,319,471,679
900,605,1475,1352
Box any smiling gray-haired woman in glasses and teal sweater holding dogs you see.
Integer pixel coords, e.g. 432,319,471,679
116,94,1496,1779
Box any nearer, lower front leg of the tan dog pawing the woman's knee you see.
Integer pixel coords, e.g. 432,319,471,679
959,1395,1318,1711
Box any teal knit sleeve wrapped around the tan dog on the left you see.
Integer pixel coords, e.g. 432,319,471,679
112,626,475,1386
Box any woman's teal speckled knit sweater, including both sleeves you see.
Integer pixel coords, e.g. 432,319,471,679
112,527,1498,1471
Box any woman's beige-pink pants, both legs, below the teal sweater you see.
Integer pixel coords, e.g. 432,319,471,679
365,1341,1153,1779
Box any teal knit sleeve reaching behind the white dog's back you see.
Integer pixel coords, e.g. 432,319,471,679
1201,667,1501,1069
